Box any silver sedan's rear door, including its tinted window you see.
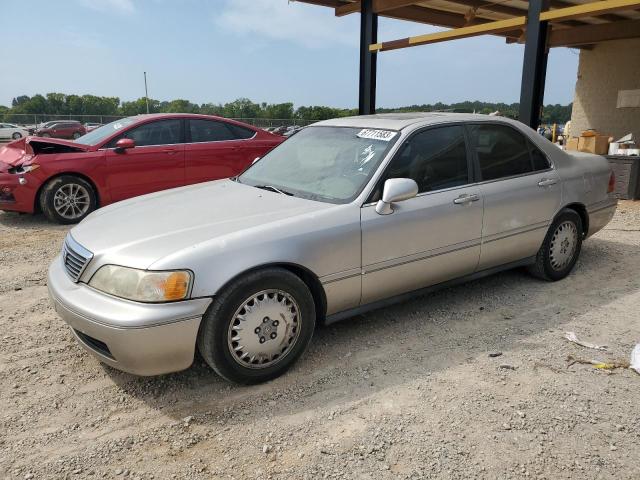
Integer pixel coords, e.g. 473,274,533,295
469,123,561,270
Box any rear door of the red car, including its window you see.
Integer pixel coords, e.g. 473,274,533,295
185,118,260,184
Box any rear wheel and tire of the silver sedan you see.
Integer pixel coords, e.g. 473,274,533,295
529,208,583,282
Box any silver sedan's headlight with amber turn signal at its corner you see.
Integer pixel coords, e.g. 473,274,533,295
89,265,192,303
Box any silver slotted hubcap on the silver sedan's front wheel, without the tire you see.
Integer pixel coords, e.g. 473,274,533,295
227,290,300,368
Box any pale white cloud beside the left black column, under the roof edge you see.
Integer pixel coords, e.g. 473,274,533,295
214,0,359,48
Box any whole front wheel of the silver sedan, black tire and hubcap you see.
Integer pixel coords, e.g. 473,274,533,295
197,268,316,384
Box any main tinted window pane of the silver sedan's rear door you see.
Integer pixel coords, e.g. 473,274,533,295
471,125,532,180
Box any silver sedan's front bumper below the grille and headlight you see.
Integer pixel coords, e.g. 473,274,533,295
48,256,211,375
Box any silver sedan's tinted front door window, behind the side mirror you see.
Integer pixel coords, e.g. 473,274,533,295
378,125,469,196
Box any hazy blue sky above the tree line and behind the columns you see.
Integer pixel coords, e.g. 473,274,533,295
0,0,578,108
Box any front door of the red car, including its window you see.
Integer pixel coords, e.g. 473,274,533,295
106,119,185,202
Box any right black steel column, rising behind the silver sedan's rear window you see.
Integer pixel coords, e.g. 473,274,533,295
519,0,549,128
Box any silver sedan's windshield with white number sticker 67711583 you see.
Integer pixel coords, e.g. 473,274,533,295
237,126,398,203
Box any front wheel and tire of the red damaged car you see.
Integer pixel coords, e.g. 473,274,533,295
40,175,97,225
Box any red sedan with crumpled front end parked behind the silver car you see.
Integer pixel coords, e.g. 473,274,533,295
0,114,284,224
